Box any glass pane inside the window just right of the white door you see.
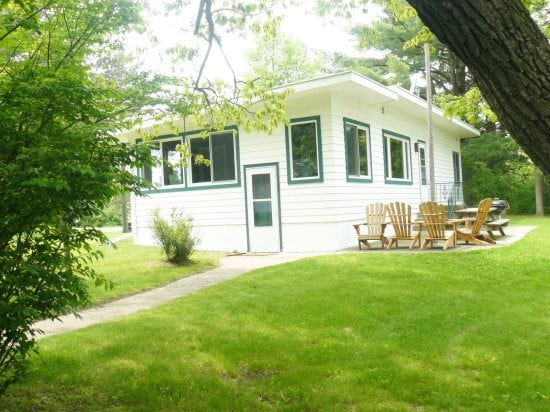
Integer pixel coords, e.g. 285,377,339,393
290,122,319,178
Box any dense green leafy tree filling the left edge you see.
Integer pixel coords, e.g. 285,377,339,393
0,0,165,394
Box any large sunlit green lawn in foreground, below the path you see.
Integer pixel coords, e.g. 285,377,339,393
0,218,550,411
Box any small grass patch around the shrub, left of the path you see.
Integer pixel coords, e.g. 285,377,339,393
87,237,224,304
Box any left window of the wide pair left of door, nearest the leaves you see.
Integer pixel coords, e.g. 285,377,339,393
142,139,183,187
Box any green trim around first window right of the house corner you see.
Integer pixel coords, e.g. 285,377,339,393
344,117,373,183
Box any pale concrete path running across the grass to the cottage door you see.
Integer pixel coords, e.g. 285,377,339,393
34,252,321,339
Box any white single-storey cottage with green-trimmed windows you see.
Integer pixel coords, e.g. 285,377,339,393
125,72,479,252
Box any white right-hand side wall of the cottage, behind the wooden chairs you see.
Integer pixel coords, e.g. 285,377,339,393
331,94,460,248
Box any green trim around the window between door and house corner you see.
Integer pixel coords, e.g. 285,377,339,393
285,116,323,184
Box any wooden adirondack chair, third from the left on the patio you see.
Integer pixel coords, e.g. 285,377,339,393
420,201,461,250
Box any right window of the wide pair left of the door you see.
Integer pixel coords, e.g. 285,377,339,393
189,132,237,184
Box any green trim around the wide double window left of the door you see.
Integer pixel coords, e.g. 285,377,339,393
136,126,241,194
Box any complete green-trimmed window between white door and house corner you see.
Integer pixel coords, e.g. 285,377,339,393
286,116,323,183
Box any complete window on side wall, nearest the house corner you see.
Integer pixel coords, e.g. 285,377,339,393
344,118,372,182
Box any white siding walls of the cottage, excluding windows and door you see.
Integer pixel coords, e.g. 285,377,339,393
132,86,468,251
